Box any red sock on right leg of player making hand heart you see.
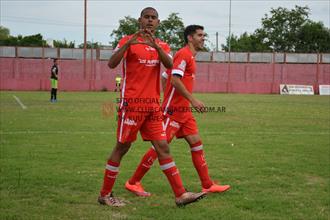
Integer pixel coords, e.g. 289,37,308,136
159,157,186,197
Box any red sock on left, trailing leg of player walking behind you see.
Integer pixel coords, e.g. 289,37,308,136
128,147,157,184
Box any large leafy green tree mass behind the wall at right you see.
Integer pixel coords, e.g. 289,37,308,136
222,6,330,53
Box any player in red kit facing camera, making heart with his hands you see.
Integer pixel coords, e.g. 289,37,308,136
98,7,205,206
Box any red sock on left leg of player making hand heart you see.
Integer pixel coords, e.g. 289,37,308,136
101,160,119,196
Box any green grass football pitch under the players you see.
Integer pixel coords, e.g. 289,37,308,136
0,92,330,220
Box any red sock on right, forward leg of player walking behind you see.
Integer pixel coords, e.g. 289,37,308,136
190,141,213,189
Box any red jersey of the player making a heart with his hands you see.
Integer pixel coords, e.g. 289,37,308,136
115,35,171,108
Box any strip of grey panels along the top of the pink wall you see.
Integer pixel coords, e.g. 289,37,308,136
0,46,330,63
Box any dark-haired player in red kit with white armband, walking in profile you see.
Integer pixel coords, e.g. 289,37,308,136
125,25,230,196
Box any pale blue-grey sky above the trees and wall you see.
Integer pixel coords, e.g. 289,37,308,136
0,0,330,48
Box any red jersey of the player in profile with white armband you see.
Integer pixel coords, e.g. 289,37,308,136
162,46,196,122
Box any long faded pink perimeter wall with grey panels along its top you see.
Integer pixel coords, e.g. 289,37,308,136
0,47,330,94
